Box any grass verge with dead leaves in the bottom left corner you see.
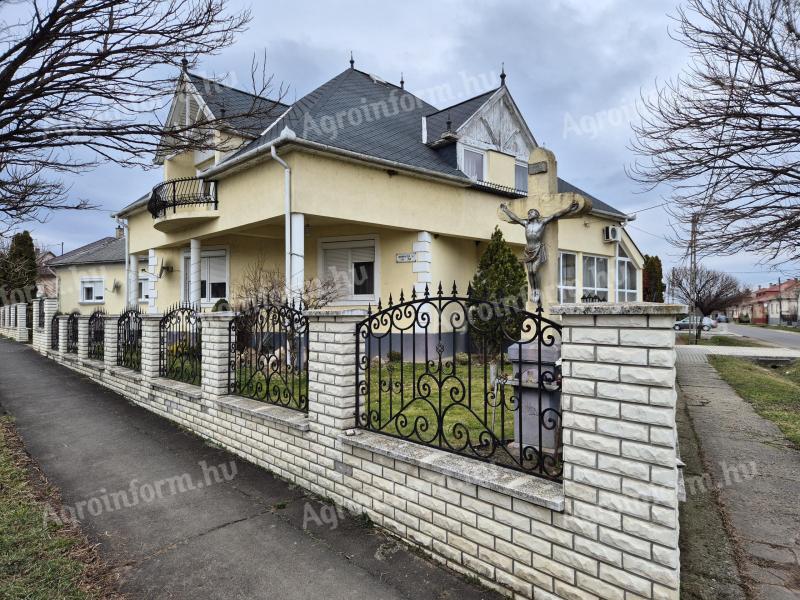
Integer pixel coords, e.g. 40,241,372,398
0,416,121,600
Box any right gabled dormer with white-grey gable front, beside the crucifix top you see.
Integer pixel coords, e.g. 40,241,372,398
422,85,537,192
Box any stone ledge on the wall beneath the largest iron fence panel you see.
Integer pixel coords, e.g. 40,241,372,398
339,429,564,512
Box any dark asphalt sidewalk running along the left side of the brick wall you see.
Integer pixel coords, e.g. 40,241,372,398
0,340,501,600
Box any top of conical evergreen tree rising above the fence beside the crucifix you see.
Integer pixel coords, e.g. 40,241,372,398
472,227,528,302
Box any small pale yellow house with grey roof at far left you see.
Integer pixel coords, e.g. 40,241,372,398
49,234,149,314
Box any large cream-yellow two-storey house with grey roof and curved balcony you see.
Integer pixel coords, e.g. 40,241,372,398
108,61,643,312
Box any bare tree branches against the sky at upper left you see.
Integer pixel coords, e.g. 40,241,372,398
0,0,283,228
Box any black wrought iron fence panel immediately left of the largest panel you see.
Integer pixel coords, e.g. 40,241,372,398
228,304,308,411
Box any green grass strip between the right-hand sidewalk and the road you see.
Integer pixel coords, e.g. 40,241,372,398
708,356,800,447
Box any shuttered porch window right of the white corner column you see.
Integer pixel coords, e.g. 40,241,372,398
321,239,377,301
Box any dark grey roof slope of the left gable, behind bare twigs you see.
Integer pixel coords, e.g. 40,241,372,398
186,73,289,138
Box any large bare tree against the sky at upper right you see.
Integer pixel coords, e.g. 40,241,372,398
632,0,800,260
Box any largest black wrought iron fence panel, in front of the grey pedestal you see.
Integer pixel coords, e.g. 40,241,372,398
356,285,562,479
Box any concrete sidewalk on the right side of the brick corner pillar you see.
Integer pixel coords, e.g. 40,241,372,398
678,348,800,600
